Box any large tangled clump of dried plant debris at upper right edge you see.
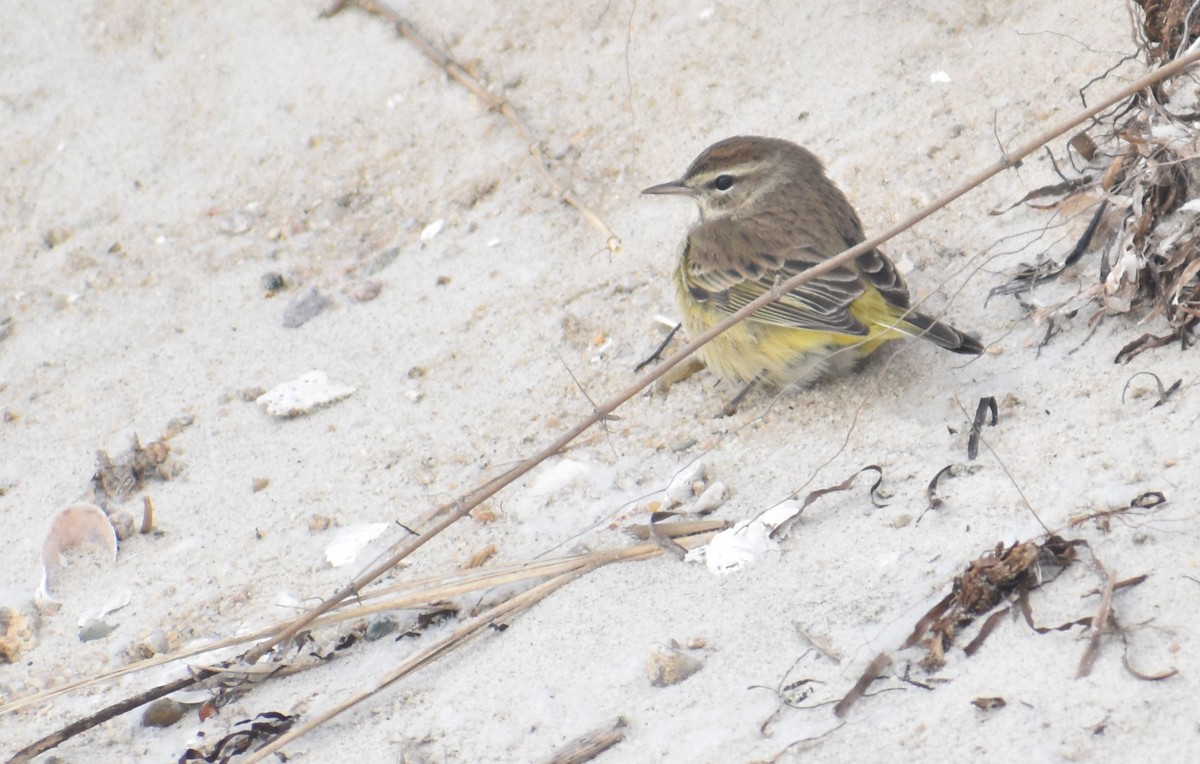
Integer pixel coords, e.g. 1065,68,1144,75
989,8,1200,363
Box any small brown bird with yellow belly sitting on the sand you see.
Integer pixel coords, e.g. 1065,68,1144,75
642,136,984,405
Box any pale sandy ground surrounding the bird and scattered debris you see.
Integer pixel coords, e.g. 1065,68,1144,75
0,0,1200,762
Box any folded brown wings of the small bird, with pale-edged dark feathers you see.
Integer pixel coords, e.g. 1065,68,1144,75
680,215,908,336
